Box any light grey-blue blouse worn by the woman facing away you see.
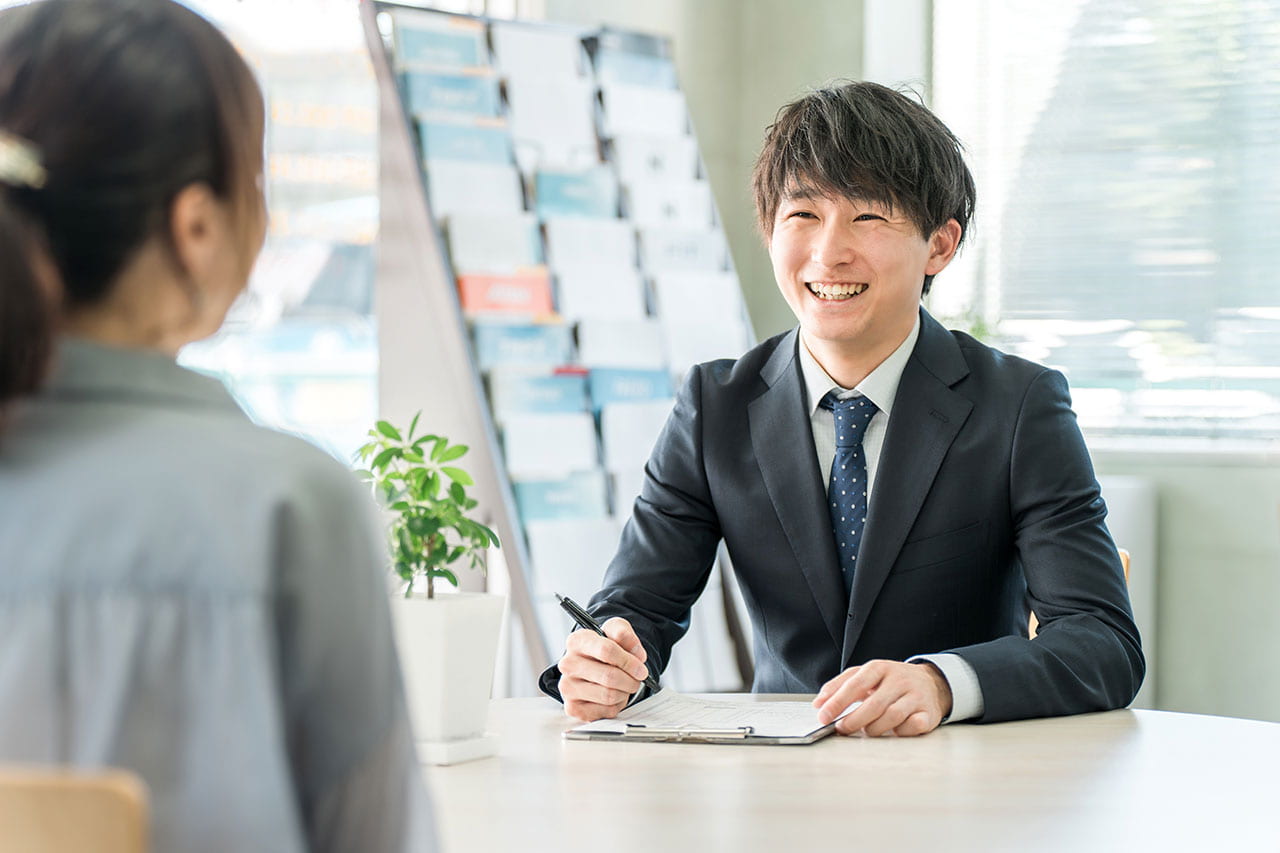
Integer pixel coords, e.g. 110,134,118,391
0,339,435,853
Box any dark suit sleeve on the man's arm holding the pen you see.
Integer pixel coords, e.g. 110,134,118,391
539,366,721,699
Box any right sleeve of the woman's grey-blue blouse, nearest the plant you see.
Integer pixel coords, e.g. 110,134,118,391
274,448,435,852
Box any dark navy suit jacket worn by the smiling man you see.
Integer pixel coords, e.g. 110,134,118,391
540,310,1144,721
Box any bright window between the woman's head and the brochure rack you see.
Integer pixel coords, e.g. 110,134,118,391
179,0,378,462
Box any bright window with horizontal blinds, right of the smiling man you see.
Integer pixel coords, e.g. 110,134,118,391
931,0,1280,439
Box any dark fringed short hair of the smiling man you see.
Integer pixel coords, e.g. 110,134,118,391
751,82,977,293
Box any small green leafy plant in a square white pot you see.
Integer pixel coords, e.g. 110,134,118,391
357,412,503,765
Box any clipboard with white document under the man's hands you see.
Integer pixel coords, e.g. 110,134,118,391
564,688,860,745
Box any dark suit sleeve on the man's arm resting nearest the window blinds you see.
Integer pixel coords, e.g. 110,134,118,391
948,370,1146,722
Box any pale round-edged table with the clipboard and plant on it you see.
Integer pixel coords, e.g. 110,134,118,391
426,695,1280,853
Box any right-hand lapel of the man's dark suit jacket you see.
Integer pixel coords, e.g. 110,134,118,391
841,309,973,666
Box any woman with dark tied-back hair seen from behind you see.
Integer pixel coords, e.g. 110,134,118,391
0,0,434,852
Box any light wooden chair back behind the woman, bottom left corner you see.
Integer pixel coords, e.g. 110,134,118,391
0,766,150,853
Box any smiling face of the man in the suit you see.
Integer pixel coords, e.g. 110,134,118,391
769,189,960,366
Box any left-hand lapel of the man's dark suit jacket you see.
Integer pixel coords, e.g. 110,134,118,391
746,330,847,647
